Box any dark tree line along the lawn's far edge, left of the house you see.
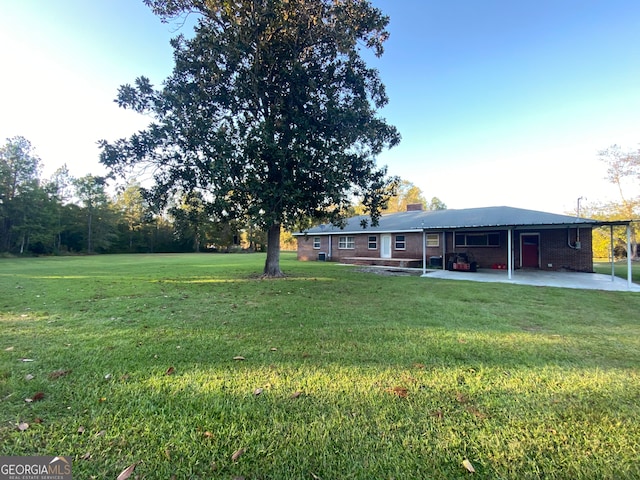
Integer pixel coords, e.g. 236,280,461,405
0,136,272,255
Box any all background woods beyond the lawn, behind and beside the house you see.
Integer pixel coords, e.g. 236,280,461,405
0,137,640,259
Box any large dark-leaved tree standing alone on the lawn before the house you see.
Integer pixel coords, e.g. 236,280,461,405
101,0,400,276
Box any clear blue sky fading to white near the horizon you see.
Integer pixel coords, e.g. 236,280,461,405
0,0,640,213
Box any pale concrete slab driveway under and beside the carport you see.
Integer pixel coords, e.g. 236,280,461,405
423,269,640,292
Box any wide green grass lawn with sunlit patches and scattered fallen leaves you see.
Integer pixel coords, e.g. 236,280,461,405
0,254,640,480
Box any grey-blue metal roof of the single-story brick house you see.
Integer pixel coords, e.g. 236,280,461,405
294,207,630,235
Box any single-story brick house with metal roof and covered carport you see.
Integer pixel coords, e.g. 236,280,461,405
294,204,630,276
